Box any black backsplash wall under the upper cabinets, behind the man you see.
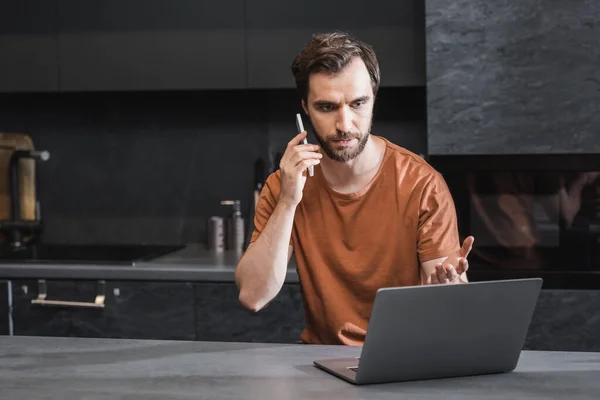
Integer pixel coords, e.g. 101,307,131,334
0,88,427,244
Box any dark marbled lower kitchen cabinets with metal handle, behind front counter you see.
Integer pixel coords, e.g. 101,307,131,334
8,280,600,351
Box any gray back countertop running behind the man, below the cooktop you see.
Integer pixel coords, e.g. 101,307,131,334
0,244,298,283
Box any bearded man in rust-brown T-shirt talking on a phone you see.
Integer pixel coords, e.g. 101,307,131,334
236,33,473,345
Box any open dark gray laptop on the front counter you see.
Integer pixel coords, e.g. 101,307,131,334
314,278,543,385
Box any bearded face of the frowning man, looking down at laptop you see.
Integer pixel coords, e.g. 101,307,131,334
303,58,374,162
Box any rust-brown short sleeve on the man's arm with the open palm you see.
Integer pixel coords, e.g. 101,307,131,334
417,172,460,262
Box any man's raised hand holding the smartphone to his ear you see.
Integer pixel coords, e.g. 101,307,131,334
279,131,323,206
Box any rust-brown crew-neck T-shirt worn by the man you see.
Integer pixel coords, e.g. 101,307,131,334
250,138,460,345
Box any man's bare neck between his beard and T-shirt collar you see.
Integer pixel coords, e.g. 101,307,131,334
321,135,385,192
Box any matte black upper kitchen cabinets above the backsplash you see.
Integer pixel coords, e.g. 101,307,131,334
0,0,425,92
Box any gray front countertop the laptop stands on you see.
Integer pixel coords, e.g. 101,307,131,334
0,336,600,400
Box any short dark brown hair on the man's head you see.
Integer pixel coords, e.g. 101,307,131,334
292,31,380,101
